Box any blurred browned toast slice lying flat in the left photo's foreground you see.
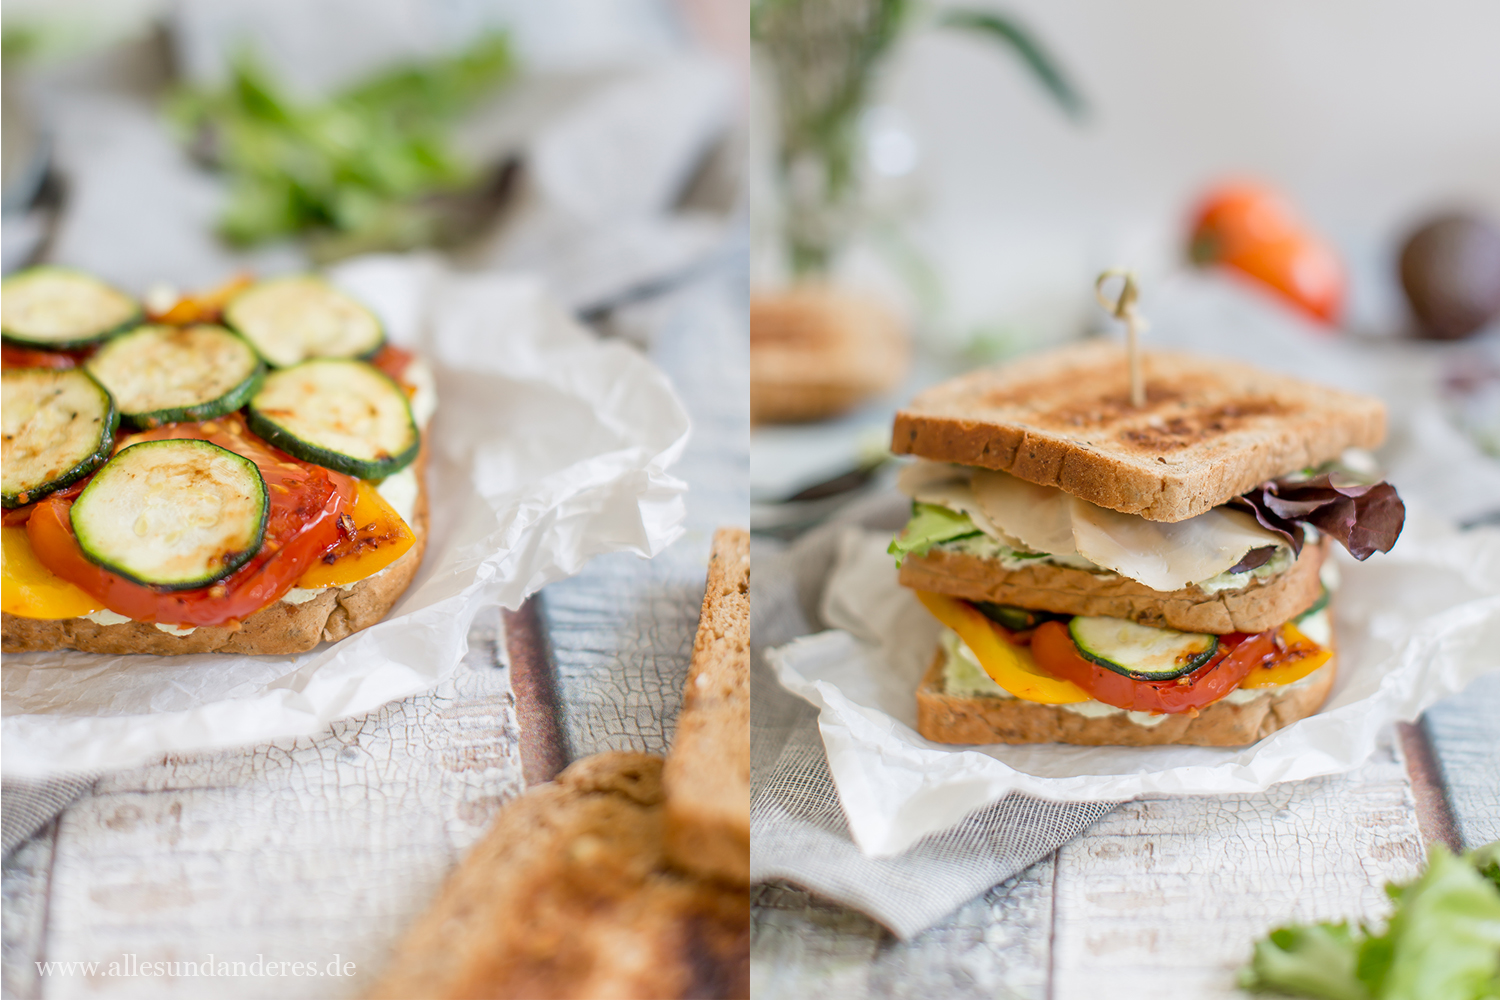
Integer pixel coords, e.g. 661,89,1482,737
369,753,750,1000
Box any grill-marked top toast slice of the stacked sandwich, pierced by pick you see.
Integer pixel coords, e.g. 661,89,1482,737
891,342,1386,522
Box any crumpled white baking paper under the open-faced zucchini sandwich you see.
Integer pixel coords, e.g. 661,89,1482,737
0,256,689,777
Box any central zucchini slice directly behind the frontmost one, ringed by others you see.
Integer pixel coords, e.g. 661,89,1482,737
84,324,266,427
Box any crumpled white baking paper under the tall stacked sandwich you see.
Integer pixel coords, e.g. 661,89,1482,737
767,510,1500,856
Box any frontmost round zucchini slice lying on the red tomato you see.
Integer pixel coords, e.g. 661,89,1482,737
69,438,270,591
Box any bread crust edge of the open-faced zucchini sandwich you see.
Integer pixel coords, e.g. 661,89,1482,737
3,442,429,657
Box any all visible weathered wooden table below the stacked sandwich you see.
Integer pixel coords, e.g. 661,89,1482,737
752,673,1500,1000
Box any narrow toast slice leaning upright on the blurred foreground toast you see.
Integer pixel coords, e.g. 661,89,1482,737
662,528,750,885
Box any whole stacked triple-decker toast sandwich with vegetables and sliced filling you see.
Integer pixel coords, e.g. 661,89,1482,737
891,342,1404,745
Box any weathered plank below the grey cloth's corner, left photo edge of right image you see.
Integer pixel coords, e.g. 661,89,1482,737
750,856,1053,1000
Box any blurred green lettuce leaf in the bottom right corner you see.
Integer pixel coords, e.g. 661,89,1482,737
1239,844,1500,1000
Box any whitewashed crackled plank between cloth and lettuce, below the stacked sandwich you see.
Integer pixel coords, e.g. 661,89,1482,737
1052,734,1425,1000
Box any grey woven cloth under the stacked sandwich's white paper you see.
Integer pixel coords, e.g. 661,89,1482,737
750,496,1115,939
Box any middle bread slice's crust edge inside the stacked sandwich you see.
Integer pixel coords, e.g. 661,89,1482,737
900,537,1329,636
